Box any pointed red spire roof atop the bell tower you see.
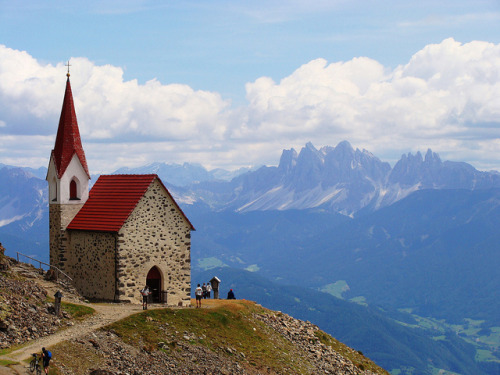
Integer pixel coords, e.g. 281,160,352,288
52,75,90,178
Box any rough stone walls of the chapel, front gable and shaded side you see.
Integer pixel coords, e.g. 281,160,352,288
57,179,191,306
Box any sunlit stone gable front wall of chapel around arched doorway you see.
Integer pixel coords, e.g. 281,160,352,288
118,179,191,306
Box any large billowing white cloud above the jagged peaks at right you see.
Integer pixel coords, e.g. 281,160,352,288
237,39,500,169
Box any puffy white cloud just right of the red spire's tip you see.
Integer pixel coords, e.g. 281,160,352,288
71,59,229,141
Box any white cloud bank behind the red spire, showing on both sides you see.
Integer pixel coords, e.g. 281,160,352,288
0,46,229,140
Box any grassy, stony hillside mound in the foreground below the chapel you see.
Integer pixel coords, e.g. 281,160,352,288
49,300,388,375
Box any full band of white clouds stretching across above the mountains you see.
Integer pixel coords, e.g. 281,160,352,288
0,39,500,172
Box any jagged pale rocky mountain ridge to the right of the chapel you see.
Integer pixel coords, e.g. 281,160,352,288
183,141,500,216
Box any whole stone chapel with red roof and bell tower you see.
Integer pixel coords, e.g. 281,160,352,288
46,72,195,306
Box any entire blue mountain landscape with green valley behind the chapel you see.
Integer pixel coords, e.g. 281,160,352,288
0,141,500,374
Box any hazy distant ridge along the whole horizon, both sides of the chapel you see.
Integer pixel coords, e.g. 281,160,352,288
0,141,500,232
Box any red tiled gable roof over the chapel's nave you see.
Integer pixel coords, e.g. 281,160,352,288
68,174,194,232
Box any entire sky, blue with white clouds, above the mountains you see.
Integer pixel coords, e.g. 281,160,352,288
0,0,500,173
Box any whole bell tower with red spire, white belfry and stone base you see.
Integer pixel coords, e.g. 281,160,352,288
46,68,90,270
